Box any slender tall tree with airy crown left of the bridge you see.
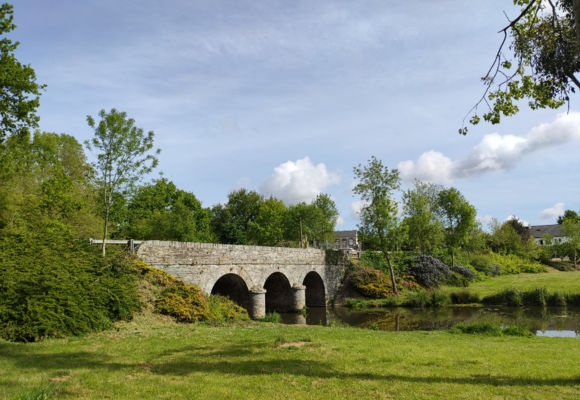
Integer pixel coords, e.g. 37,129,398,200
85,108,160,256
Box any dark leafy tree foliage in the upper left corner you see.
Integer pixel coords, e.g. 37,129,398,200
0,3,45,143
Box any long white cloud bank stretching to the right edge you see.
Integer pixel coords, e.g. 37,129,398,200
398,112,580,184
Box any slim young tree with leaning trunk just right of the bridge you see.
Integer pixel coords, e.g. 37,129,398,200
353,156,401,295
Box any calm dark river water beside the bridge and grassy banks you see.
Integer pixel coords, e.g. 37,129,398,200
282,307,580,338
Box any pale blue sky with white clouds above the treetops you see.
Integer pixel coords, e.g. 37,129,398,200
11,0,580,229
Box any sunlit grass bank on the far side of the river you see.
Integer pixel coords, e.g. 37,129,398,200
442,268,580,296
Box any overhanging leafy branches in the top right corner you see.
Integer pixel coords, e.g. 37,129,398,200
459,0,580,135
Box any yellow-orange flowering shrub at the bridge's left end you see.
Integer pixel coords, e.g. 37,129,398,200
155,281,210,322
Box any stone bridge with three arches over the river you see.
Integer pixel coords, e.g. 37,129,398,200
137,241,346,318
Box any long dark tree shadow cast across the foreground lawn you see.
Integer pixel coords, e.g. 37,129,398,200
0,343,580,388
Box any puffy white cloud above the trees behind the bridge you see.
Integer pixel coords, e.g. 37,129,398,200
260,157,340,204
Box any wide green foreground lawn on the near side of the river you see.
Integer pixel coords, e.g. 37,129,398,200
0,316,580,399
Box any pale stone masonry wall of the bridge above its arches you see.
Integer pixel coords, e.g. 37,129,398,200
137,241,344,301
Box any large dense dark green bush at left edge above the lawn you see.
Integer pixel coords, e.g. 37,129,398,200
0,232,139,341
